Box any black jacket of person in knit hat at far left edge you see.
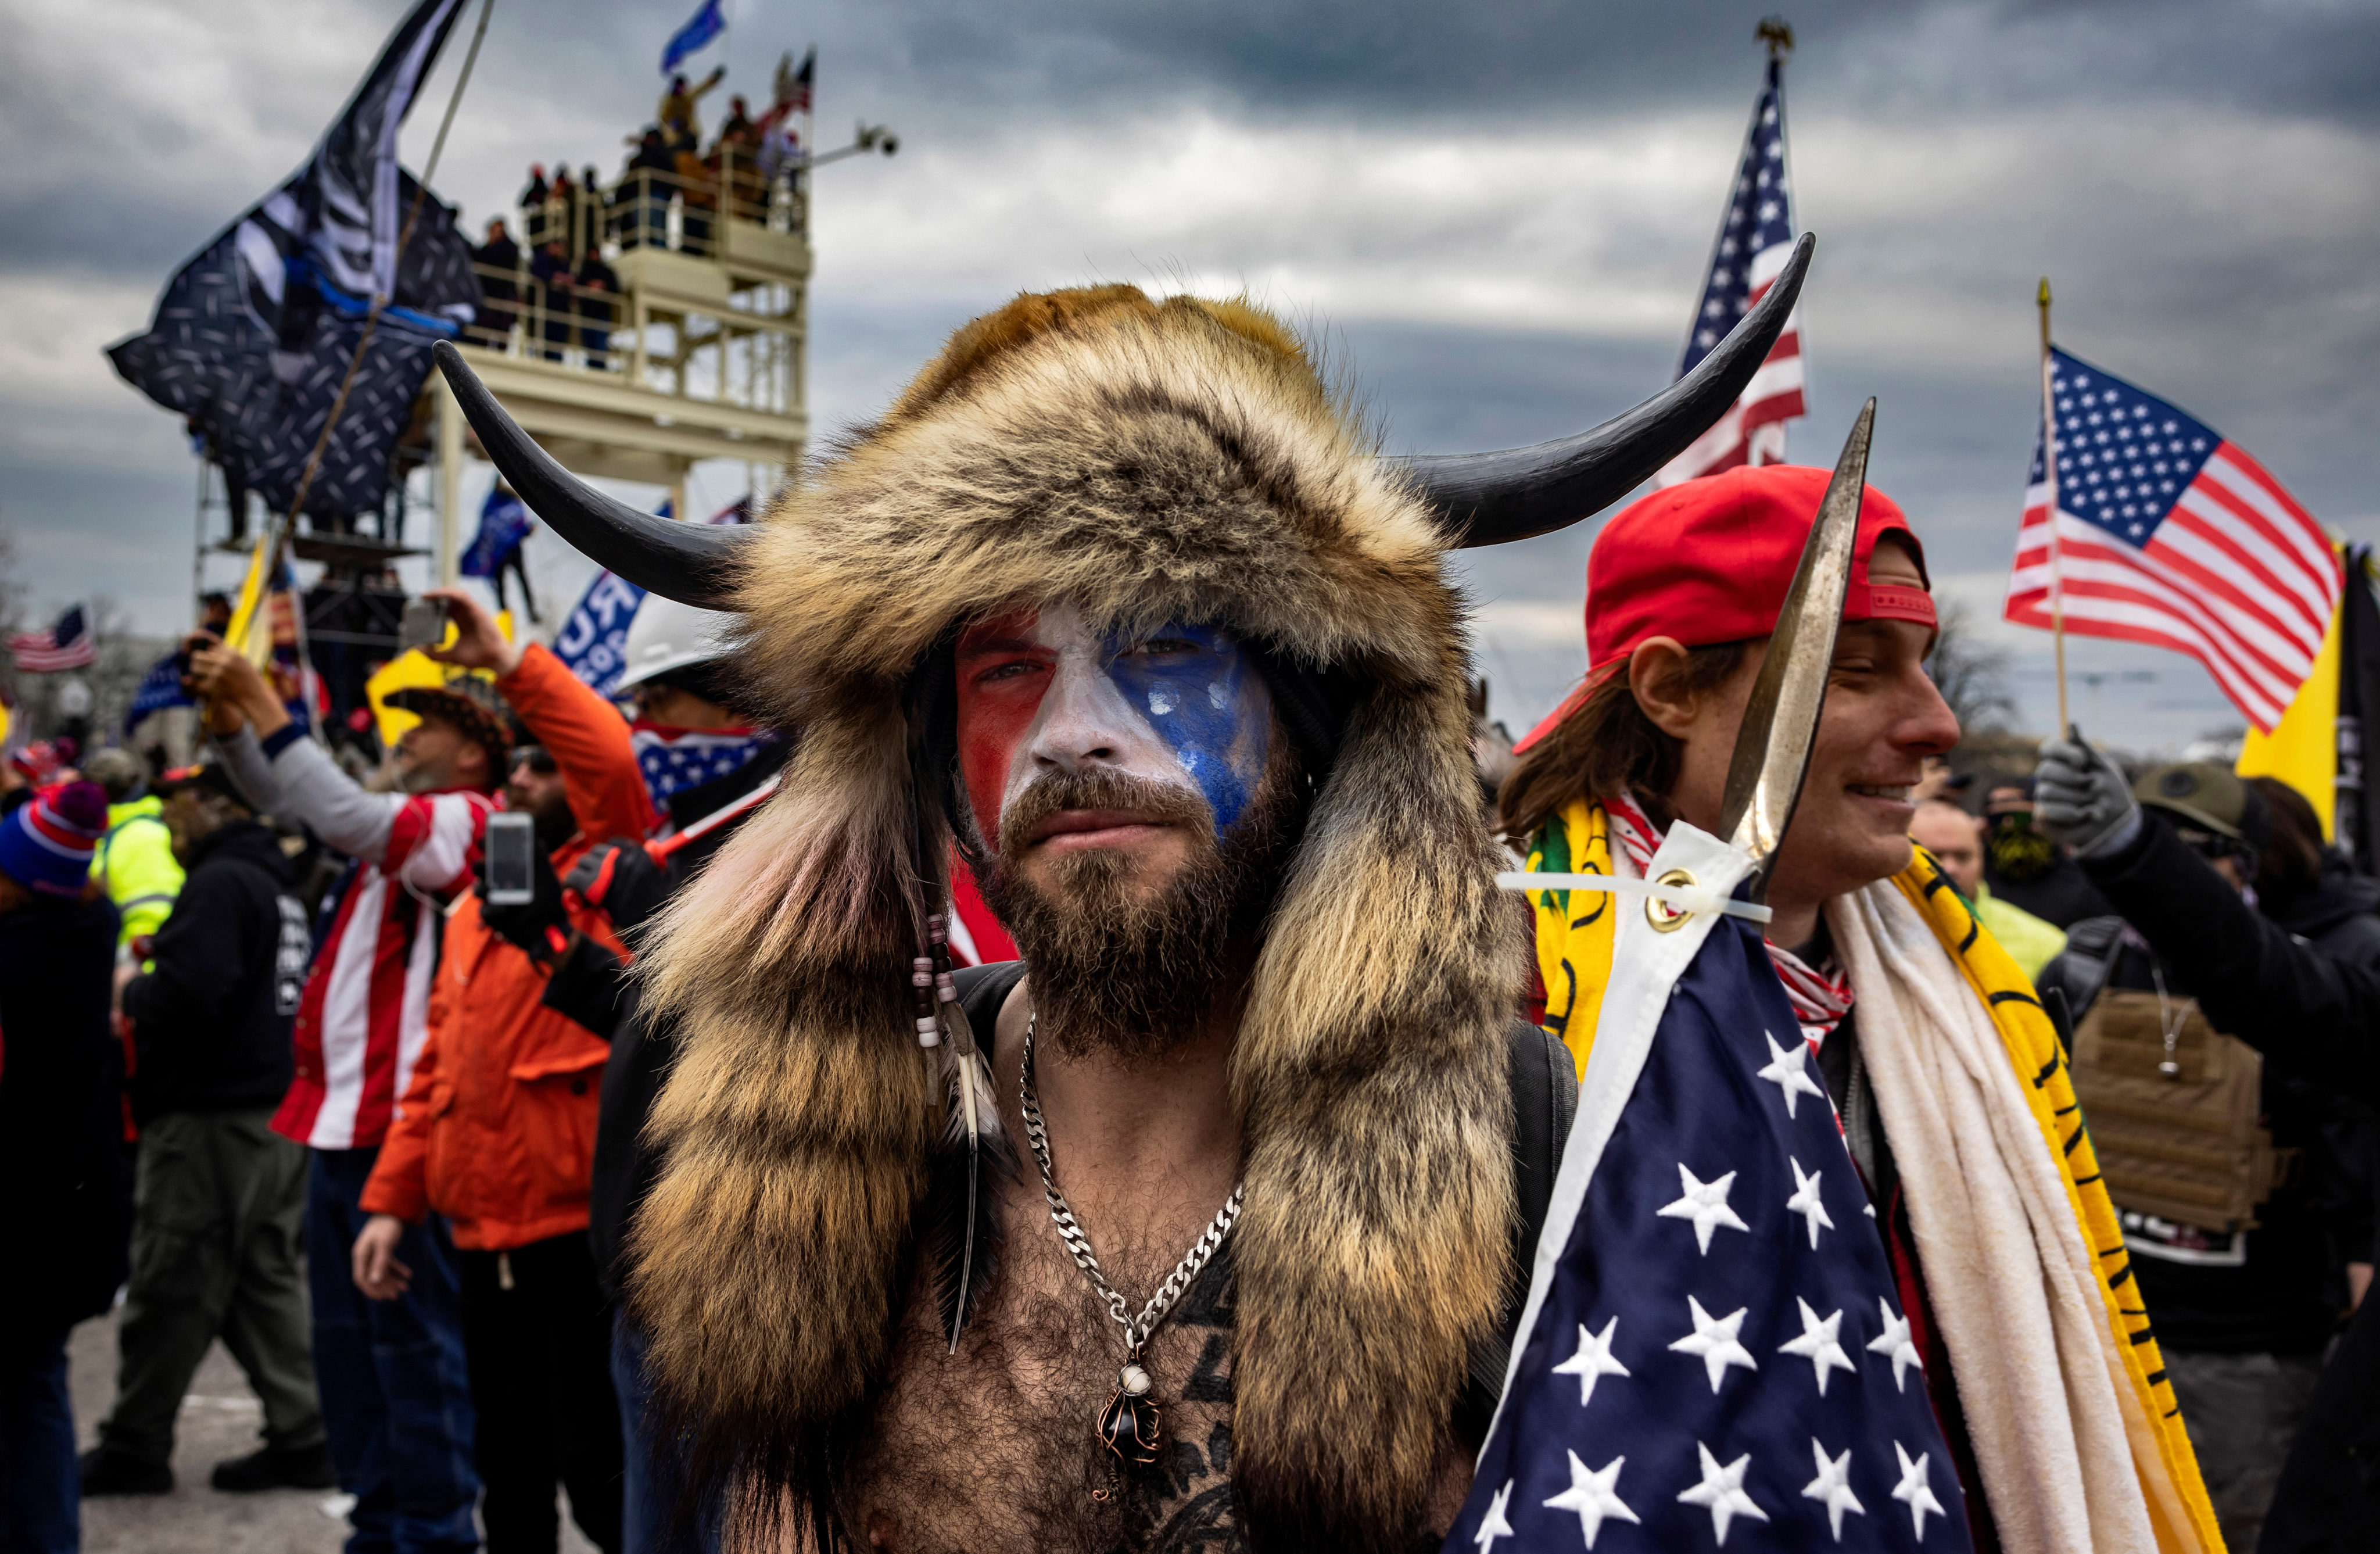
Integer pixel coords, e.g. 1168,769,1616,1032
0,895,131,1352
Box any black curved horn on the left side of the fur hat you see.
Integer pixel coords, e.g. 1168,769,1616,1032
433,341,754,609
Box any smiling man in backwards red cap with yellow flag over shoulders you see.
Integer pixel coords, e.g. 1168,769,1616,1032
1499,467,2221,1554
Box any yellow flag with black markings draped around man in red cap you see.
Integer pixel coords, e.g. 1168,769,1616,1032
1528,800,2223,1554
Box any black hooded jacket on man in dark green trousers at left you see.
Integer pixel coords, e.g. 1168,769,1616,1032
124,821,312,1121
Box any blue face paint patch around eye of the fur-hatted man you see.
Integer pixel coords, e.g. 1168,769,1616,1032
1107,624,1273,830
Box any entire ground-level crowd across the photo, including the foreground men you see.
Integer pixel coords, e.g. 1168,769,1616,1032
0,278,2380,1554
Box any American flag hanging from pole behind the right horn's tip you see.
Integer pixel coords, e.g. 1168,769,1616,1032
1654,59,1806,485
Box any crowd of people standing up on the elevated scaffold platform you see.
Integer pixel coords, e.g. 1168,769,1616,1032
471,69,790,371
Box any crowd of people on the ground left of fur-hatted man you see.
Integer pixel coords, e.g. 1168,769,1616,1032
0,593,786,1552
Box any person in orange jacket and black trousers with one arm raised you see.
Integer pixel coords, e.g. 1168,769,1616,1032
354,588,654,1554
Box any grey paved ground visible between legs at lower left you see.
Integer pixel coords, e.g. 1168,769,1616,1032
71,1316,593,1554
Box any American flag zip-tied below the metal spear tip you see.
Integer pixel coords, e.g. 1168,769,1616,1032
1445,823,1970,1554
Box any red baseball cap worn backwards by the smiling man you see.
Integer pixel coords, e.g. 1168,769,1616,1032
1514,464,1935,750
